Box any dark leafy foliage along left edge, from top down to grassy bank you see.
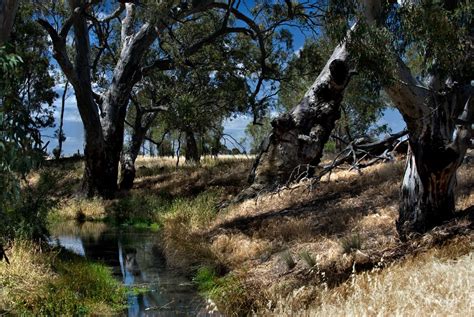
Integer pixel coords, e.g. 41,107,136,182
0,5,56,244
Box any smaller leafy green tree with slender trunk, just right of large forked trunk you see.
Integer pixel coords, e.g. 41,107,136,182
120,47,251,189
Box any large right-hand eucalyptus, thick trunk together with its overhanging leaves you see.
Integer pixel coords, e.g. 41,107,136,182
367,0,474,238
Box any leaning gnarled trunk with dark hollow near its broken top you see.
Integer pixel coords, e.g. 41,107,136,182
238,42,350,200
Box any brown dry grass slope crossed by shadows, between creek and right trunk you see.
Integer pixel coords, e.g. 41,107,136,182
160,160,474,316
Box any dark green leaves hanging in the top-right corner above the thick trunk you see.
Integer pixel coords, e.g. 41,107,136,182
397,0,474,77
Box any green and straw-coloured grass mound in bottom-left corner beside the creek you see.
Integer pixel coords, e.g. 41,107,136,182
0,241,125,316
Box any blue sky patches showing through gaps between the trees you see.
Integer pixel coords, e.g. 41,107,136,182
42,0,405,156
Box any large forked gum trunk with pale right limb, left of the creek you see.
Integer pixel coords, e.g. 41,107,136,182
38,0,215,198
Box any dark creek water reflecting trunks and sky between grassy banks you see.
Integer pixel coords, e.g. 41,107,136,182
51,222,215,317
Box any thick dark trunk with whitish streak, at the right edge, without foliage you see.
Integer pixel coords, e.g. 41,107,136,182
387,69,474,239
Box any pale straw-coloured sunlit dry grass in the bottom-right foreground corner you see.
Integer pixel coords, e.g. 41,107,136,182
268,238,474,316
